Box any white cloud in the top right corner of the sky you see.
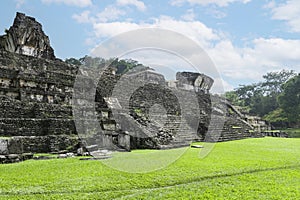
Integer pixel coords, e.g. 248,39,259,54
266,0,300,32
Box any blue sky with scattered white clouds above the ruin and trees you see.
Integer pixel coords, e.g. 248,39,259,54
0,0,300,90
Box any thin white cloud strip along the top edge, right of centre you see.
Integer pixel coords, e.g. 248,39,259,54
170,0,251,7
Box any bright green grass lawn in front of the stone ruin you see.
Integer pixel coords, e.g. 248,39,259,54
0,137,300,199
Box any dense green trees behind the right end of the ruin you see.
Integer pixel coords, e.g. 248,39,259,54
225,70,300,128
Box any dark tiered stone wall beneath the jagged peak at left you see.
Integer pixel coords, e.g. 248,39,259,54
0,48,79,153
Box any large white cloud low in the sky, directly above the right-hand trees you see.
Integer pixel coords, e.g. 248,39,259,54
207,38,300,81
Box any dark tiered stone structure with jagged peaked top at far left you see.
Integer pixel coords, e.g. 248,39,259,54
0,13,78,154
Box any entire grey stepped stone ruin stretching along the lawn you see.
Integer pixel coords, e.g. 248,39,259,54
0,13,257,162
